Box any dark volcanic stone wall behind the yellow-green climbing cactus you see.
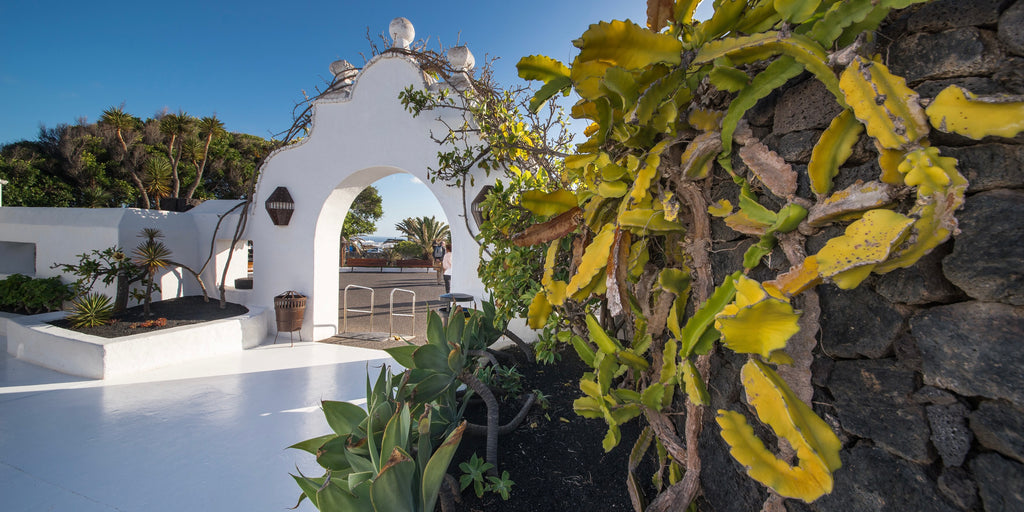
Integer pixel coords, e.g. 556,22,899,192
700,0,1024,512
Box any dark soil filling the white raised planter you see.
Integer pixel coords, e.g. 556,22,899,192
50,295,249,338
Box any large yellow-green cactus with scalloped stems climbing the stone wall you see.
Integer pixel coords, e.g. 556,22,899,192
401,0,1021,505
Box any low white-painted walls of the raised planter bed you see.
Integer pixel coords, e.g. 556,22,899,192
7,306,267,379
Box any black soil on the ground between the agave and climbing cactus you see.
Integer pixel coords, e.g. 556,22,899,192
449,349,638,512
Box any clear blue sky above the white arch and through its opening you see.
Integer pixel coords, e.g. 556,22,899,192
0,0,710,236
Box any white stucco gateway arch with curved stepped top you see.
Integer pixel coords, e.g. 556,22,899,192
247,53,493,340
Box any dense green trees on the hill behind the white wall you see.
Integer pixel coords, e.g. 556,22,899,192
0,105,280,207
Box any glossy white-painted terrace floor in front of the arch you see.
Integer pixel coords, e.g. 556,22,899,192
0,337,393,512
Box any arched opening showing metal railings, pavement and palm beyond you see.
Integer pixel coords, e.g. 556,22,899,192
332,172,452,348
